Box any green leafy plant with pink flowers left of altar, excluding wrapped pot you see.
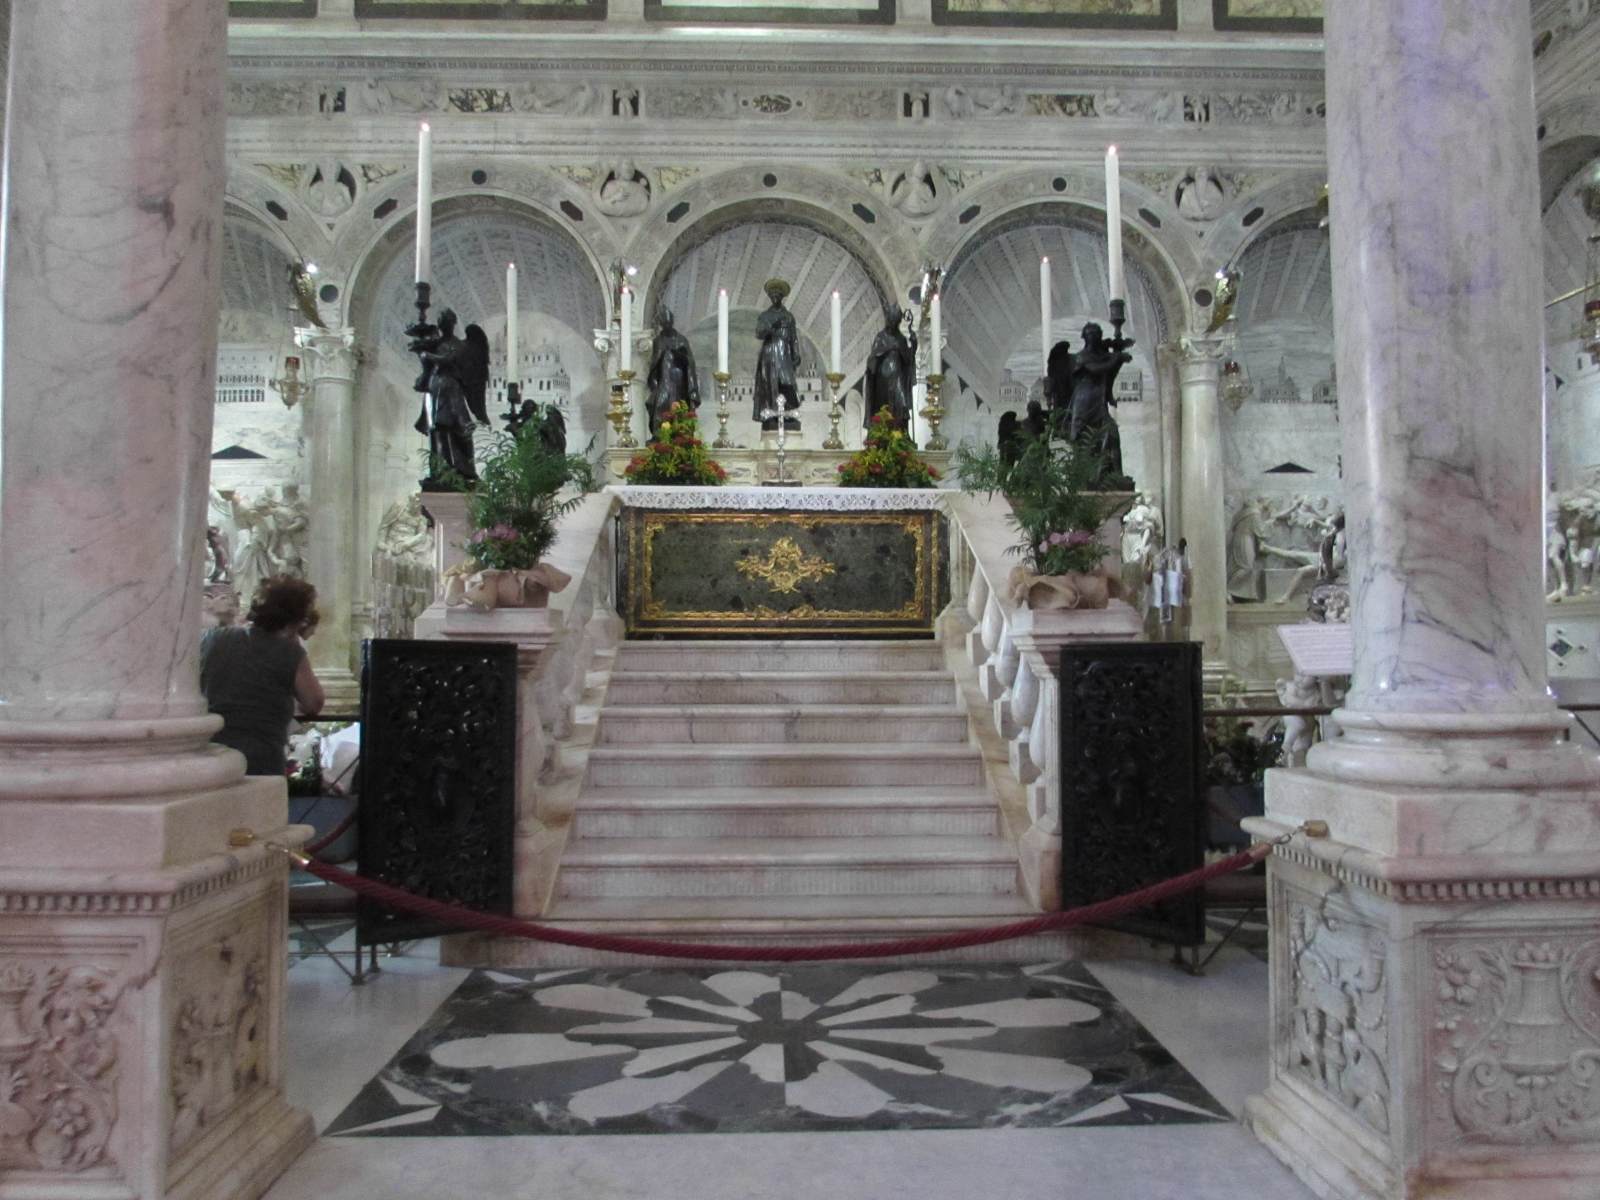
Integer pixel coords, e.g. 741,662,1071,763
461,422,598,571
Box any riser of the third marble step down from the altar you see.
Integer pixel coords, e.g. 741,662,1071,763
600,710,966,746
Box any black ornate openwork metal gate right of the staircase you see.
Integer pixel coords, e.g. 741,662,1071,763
1061,642,1205,946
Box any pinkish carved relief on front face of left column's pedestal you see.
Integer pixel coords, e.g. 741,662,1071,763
0,962,122,1174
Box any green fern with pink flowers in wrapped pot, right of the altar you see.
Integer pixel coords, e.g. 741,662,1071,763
955,437,1122,608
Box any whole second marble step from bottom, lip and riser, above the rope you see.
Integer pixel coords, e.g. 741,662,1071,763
557,837,1016,917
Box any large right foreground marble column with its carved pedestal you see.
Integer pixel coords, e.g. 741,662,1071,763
1248,0,1600,1200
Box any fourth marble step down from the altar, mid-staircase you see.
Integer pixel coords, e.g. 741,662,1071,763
584,742,984,792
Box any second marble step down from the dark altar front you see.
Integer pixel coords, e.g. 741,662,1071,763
606,669,955,709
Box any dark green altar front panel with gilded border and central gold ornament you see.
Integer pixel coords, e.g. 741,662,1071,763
621,507,949,638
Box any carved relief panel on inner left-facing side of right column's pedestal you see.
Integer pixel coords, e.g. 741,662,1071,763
1278,901,1390,1134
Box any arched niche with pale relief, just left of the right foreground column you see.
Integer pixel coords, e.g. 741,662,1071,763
1222,208,1344,572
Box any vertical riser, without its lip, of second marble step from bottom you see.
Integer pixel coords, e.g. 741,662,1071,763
558,861,1016,917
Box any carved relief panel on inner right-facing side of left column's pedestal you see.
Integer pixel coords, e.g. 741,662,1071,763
170,923,267,1152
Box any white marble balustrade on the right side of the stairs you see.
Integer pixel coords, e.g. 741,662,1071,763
949,493,1142,910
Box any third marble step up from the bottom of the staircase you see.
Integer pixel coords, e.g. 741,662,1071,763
573,787,1000,838
